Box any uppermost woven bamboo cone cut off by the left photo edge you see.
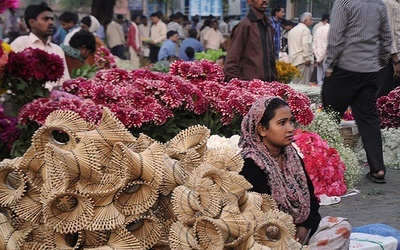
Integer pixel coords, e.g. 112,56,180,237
0,158,26,207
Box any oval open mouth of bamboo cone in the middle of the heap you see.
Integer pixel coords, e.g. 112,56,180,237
114,181,158,215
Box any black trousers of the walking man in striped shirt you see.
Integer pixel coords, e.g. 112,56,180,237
322,68,386,173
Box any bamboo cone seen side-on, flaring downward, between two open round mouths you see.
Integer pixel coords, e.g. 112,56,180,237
88,194,125,231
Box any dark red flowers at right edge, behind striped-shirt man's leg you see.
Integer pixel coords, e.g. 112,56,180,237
376,87,400,128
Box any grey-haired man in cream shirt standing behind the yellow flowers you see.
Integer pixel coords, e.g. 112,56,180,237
288,12,314,84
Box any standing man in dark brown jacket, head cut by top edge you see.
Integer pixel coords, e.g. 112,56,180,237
224,0,277,81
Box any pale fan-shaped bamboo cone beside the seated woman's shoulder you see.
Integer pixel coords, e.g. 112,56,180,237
205,147,244,173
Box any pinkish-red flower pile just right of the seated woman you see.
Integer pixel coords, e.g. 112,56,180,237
294,129,347,197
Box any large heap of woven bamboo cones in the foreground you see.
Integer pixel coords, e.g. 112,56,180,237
0,108,301,250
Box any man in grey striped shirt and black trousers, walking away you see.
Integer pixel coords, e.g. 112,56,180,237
322,0,392,183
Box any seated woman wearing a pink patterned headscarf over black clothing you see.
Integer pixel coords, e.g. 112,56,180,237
239,97,351,249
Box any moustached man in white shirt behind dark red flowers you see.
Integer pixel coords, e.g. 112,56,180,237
10,4,70,90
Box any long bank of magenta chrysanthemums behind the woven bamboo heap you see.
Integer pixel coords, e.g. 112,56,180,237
19,60,313,142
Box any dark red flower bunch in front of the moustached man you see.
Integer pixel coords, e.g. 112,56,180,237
3,48,64,116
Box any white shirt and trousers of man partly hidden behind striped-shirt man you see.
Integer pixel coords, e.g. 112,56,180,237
313,20,330,85
